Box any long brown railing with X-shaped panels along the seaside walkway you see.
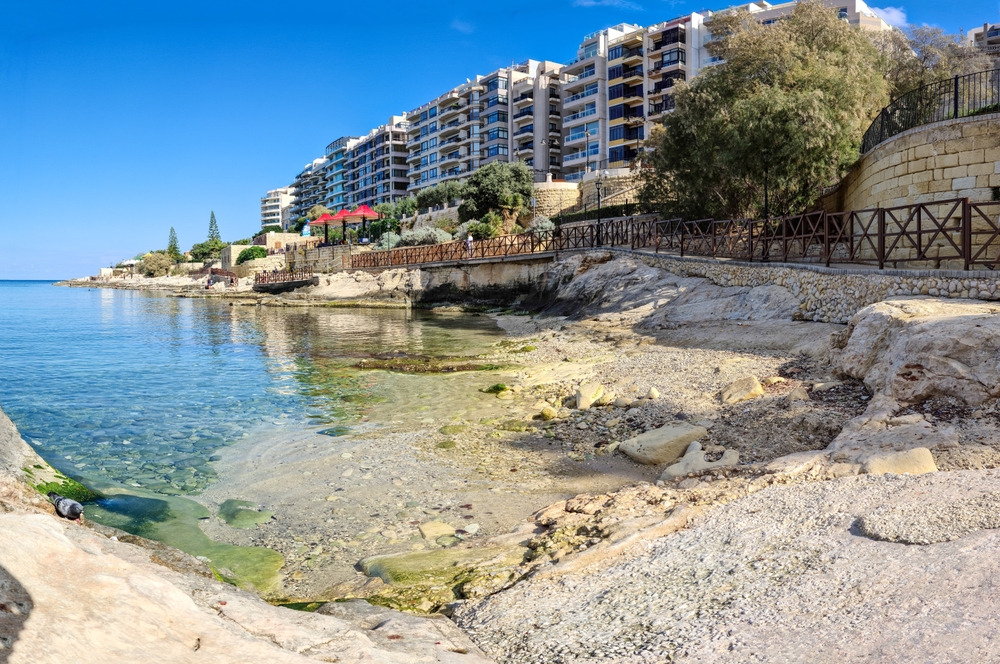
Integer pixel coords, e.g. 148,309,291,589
350,198,1000,270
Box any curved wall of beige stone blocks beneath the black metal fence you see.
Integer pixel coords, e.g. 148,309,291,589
823,113,1000,212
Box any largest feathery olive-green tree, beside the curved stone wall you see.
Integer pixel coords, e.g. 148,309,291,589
641,1,888,219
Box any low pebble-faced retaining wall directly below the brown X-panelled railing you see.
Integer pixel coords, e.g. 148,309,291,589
612,249,1000,323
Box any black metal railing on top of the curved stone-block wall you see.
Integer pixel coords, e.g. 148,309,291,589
861,69,1000,155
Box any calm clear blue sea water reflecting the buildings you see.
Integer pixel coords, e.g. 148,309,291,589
0,281,501,495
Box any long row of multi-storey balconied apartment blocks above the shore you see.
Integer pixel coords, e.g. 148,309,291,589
280,0,892,210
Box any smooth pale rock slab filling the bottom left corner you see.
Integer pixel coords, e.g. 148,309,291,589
0,404,489,664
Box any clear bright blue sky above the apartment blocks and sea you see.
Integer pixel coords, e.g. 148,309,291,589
0,0,1000,279
